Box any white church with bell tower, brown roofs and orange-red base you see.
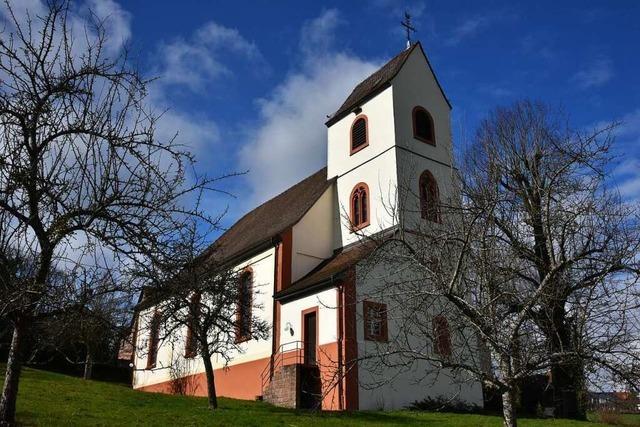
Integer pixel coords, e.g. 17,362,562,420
126,43,482,410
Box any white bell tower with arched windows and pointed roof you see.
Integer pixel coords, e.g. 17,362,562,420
326,41,452,248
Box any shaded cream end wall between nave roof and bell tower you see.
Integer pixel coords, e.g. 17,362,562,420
291,186,336,281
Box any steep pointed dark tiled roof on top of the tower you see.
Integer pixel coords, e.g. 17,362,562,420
325,42,451,126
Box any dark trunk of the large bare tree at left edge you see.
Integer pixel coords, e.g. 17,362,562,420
0,323,26,426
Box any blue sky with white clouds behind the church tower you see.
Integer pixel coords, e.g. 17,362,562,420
6,0,640,231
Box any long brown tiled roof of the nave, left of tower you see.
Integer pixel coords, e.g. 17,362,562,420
205,167,333,262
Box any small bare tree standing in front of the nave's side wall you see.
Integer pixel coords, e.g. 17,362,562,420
139,217,270,409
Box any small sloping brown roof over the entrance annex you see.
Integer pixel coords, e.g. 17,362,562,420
275,243,375,299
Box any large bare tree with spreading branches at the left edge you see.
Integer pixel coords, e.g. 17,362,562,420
0,1,222,425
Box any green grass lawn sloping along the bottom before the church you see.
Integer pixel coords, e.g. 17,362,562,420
0,365,640,427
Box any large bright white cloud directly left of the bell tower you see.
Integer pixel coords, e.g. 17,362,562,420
240,9,378,204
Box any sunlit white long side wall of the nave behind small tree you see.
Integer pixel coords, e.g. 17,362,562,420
133,248,275,388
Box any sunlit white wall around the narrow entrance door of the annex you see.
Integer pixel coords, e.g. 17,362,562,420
280,288,338,350
